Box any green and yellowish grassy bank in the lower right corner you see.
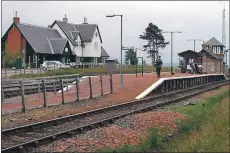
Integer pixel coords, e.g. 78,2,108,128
164,90,229,152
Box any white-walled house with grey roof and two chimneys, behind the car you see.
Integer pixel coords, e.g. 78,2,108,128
50,16,109,63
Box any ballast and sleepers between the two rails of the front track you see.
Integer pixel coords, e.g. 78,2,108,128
2,93,184,148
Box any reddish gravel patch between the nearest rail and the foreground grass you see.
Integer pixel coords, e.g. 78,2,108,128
26,86,229,152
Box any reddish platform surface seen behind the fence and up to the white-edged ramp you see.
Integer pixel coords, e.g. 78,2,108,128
2,72,196,114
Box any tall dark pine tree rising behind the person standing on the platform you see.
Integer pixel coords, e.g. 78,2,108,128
139,23,169,65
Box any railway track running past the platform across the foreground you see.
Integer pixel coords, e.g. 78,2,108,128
2,80,229,153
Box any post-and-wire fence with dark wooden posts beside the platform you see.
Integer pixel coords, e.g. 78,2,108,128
1,75,113,114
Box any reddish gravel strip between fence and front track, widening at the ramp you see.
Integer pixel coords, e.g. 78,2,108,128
2,73,194,129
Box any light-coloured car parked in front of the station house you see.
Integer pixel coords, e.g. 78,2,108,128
41,61,70,71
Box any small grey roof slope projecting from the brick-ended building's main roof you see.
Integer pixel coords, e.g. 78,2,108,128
48,38,67,54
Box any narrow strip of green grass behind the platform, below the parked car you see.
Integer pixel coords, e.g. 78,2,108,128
10,66,170,79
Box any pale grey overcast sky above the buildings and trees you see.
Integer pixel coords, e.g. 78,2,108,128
2,1,229,63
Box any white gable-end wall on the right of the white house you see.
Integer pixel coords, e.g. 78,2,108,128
83,29,101,57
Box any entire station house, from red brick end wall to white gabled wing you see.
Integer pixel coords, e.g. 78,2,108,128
1,13,109,67
